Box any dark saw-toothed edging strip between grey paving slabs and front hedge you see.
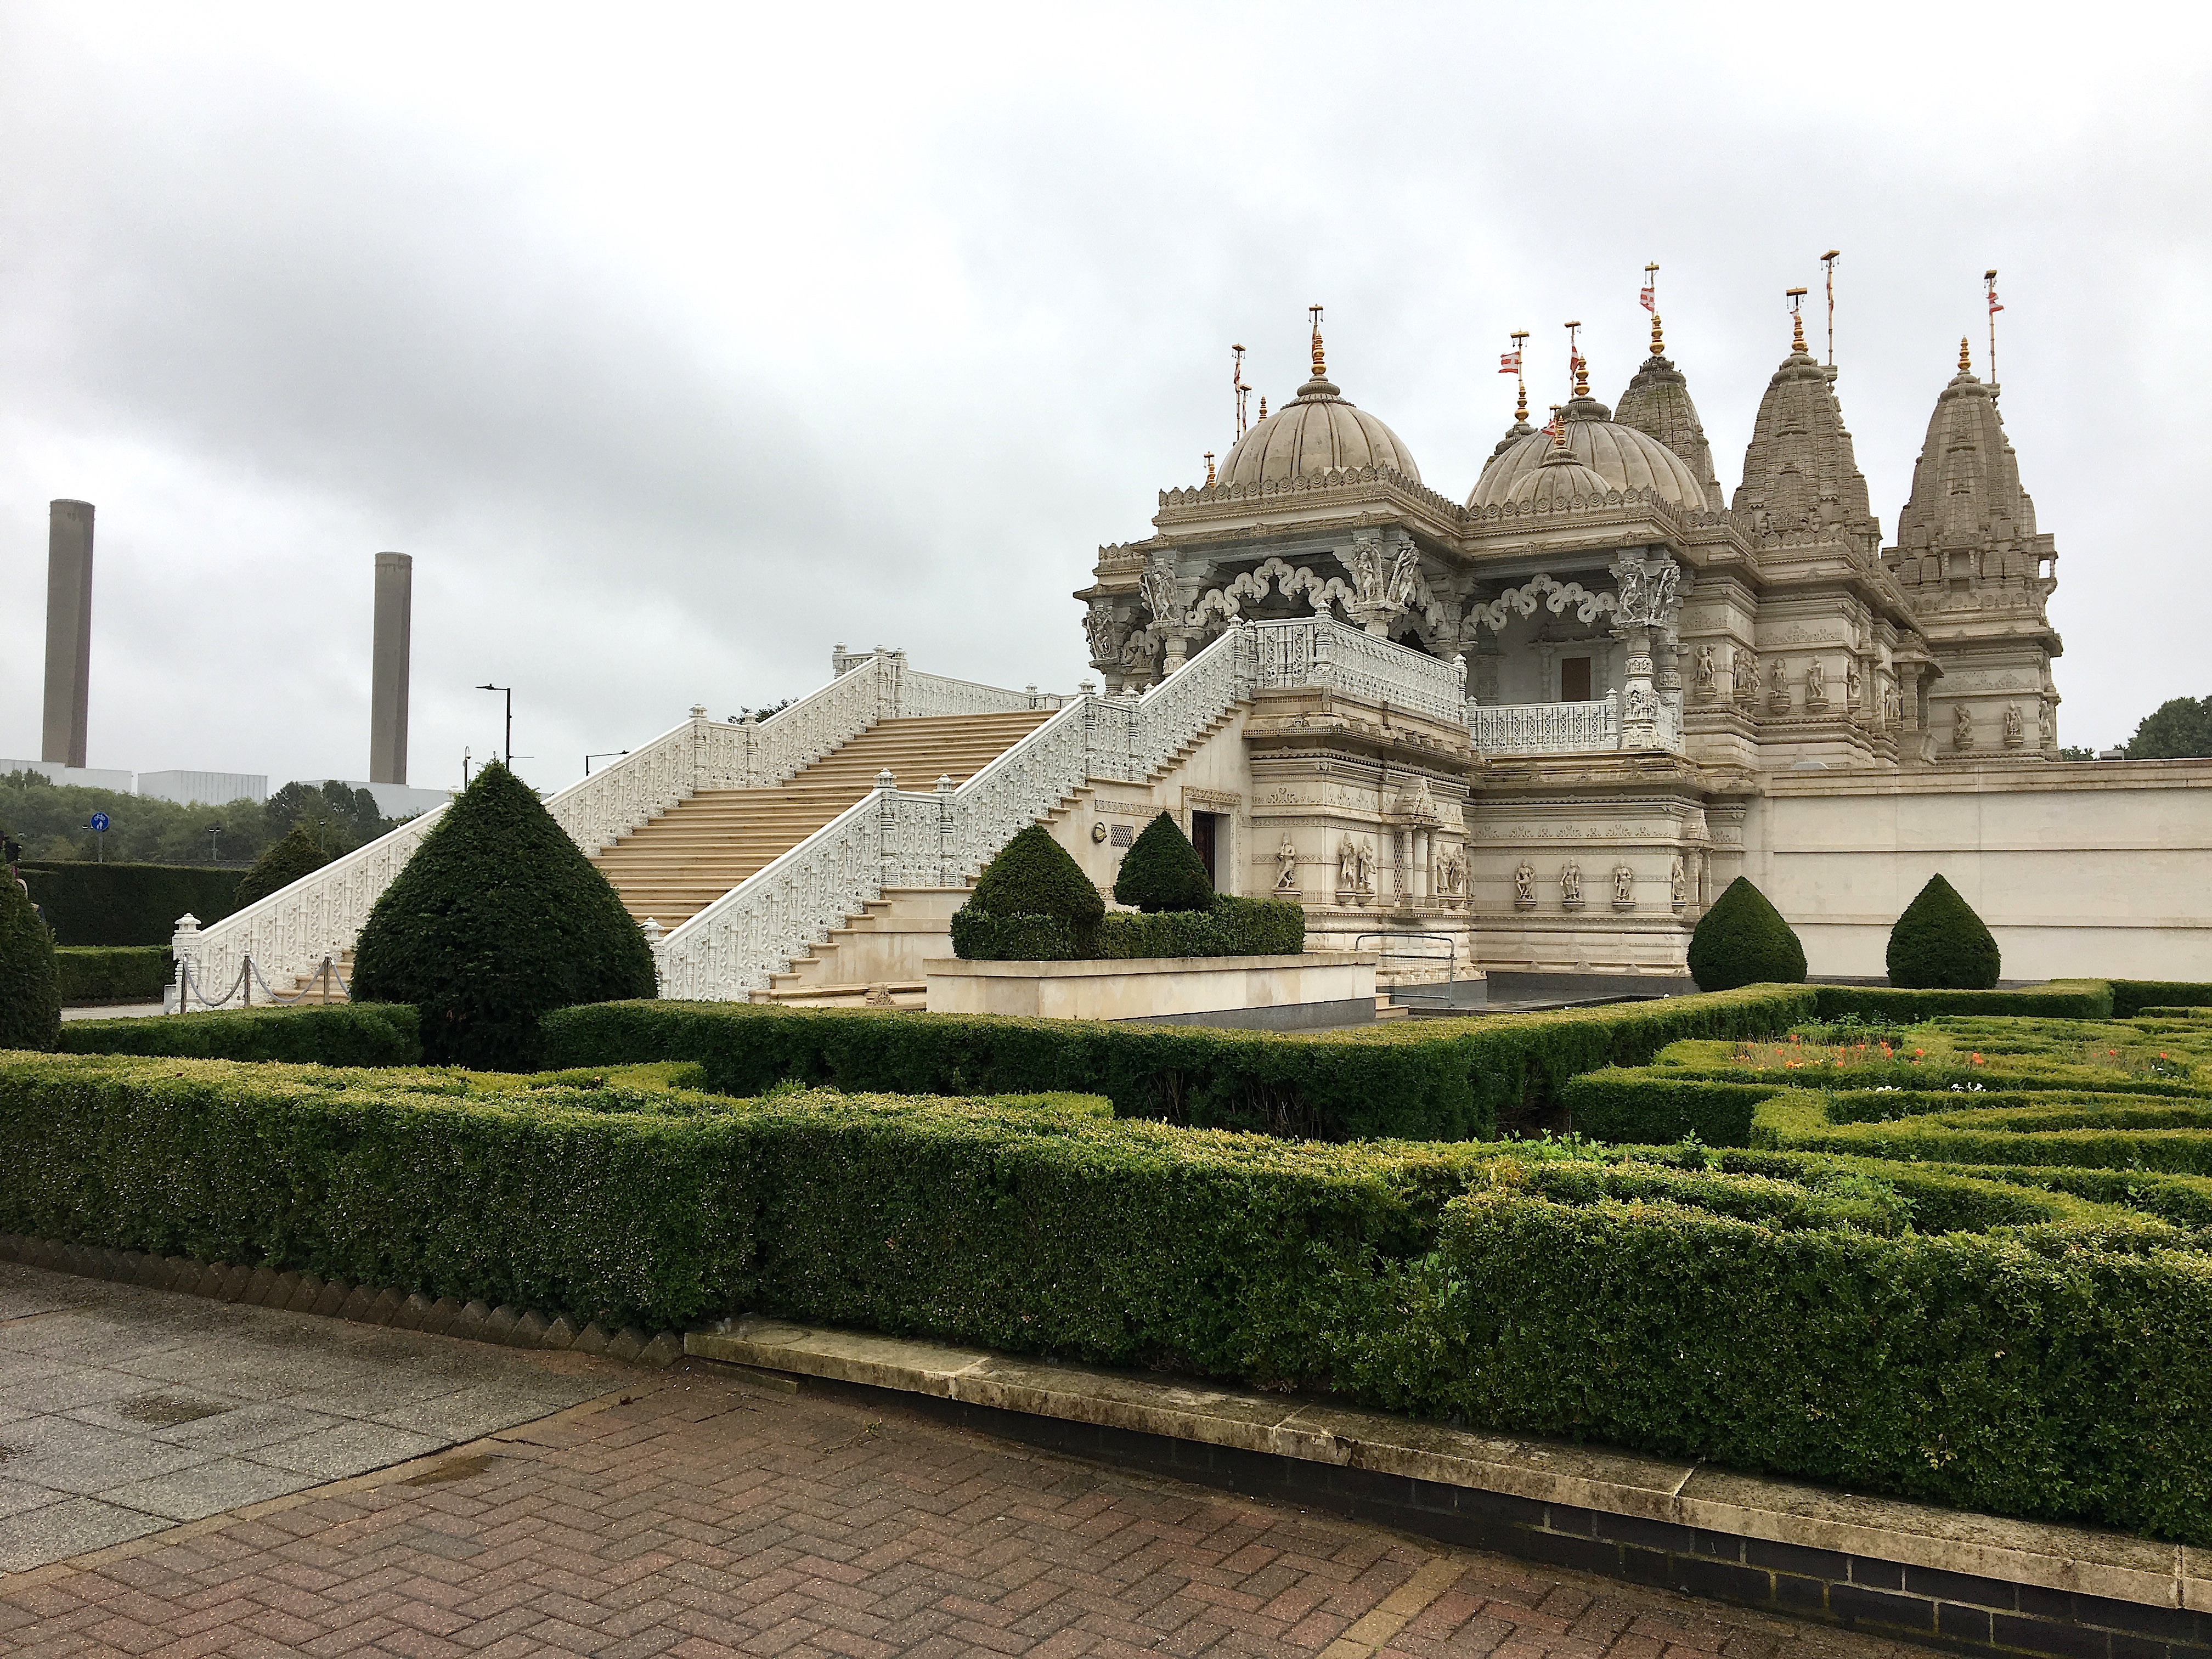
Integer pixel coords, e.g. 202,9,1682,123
0,1232,684,1367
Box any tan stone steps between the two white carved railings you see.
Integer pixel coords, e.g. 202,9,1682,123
593,710,1051,938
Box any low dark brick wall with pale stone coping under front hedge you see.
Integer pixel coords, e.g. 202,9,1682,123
684,1318,2212,1659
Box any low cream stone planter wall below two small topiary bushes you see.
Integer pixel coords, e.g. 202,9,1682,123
922,951,1376,1020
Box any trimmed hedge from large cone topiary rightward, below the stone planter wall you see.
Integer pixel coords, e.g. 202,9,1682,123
542,984,1812,1142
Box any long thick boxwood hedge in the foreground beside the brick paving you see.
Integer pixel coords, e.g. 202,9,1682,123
0,1055,2212,1544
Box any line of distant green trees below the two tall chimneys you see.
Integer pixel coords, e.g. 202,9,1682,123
0,772,405,865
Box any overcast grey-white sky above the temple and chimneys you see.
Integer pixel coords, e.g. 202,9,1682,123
0,0,2212,787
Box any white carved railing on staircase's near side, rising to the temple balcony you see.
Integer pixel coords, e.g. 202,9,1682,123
654,617,1460,1000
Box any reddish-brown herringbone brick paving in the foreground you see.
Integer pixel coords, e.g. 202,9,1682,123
0,1338,1938,1659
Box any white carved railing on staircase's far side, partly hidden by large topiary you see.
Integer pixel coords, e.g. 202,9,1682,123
190,650,1044,984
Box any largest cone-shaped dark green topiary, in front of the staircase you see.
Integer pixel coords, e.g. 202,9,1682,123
352,761,654,1070
